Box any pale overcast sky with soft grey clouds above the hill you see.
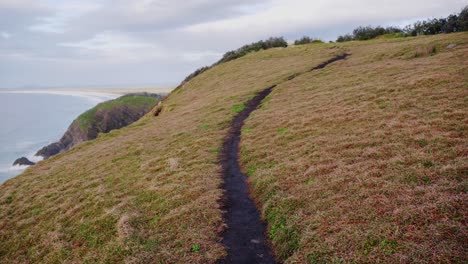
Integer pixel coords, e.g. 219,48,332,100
0,0,466,88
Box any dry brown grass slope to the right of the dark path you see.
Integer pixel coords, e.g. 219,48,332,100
241,33,468,263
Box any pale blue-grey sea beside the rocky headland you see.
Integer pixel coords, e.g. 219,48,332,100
0,91,117,184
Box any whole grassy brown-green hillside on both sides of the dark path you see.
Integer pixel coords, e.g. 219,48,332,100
0,33,468,263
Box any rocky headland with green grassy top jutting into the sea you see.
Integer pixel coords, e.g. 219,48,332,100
36,93,161,159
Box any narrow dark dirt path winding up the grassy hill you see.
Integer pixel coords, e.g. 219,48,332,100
219,53,350,264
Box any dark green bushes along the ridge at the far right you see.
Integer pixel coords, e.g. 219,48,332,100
336,6,468,42
